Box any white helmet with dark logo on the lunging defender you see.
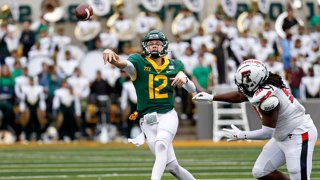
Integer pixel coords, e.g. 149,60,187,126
235,59,269,97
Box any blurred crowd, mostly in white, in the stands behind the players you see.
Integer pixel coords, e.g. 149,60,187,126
0,0,320,143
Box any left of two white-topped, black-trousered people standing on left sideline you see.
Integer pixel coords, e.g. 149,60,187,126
19,77,46,142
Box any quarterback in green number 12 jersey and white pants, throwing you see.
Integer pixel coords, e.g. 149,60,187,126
103,30,196,180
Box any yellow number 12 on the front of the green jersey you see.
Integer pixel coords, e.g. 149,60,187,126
148,74,168,99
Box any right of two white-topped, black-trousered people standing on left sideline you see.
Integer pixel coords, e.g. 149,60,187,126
53,81,81,142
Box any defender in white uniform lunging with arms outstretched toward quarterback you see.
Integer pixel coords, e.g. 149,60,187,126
193,59,318,180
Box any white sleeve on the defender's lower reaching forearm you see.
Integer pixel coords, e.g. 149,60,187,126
240,125,274,140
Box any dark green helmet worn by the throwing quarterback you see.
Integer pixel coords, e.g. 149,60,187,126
142,30,169,58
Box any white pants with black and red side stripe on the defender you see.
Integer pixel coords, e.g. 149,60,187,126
252,126,318,180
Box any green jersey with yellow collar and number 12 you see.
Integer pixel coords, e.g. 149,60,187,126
128,53,184,115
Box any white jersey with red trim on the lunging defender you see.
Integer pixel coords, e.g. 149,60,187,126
248,85,313,141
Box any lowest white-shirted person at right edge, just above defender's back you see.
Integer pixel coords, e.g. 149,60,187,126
300,67,320,100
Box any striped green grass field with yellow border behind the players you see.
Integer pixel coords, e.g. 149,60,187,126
0,142,320,180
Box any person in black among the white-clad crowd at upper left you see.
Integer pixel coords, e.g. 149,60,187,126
20,21,36,57
